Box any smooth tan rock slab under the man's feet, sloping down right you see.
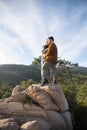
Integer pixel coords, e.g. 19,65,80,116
42,84,69,112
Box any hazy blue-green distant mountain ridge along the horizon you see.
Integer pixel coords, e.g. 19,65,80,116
0,64,87,86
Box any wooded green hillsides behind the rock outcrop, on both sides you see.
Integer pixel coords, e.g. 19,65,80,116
0,62,87,130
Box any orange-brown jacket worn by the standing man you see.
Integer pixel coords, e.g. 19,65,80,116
45,43,57,64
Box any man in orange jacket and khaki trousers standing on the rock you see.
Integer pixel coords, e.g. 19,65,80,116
41,36,58,86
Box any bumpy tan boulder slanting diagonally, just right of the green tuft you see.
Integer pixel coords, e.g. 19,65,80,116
27,85,59,111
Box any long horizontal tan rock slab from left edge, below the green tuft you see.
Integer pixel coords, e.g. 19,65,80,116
0,102,47,119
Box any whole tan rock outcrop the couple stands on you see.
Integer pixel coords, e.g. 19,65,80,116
0,84,73,130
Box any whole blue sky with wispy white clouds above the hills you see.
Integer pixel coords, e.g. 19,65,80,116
0,0,87,67
